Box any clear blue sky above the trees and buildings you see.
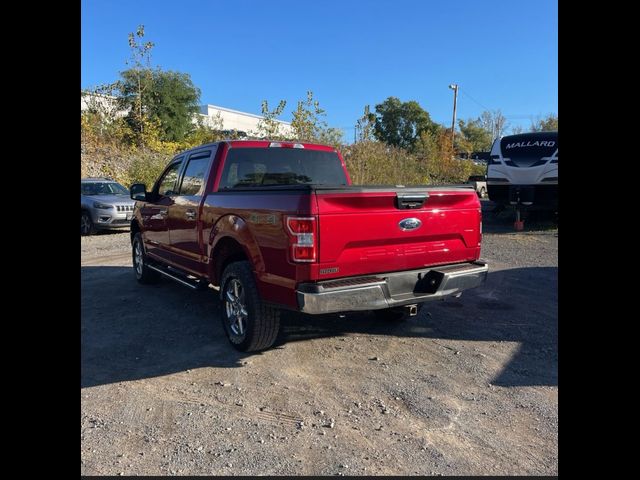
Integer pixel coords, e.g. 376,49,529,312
81,0,558,140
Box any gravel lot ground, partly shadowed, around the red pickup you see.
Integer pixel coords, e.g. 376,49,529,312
81,202,558,475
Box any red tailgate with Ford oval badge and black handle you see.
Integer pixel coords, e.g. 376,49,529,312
316,187,481,279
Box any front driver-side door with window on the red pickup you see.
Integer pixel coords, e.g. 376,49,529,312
140,157,184,260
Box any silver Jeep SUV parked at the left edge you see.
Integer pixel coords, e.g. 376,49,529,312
80,178,135,235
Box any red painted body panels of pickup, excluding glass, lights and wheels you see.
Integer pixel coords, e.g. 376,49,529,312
138,141,481,309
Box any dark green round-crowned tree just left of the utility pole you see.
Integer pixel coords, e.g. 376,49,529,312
374,97,437,151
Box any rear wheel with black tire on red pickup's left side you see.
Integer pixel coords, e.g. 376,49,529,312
220,261,280,352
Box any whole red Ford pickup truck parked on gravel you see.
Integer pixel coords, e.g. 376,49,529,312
130,140,488,351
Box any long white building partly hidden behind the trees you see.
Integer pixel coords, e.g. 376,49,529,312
80,93,293,136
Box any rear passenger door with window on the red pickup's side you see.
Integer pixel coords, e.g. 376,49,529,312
167,146,216,274
